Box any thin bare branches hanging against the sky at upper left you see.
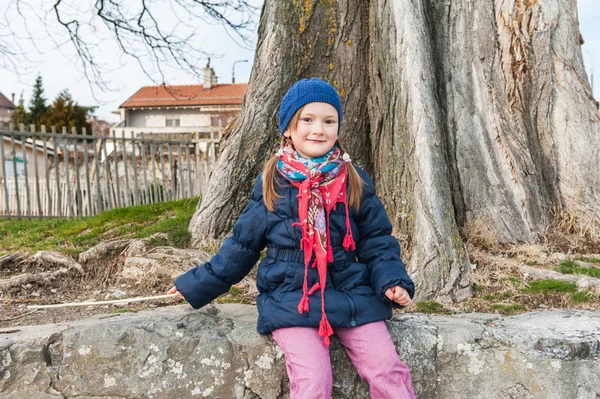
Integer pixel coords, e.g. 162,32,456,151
0,0,258,91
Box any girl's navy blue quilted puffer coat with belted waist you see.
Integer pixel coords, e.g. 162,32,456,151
175,168,414,334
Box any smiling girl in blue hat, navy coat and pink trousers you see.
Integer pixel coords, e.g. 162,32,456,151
169,78,414,399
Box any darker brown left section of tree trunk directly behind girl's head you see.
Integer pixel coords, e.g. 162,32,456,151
189,0,371,248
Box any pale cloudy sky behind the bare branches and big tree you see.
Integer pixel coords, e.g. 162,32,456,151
0,0,600,122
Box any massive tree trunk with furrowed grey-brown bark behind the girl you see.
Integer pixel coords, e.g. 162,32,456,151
190,0,600,301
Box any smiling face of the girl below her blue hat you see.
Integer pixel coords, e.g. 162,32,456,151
283,103,339,158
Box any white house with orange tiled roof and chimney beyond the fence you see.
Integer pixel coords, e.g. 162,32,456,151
111,64,248,138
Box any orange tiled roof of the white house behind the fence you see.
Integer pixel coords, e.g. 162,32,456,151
119,83,248,108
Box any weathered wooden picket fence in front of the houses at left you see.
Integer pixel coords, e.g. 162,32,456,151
0,125,219,218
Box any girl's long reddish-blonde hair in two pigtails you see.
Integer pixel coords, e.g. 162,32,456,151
262,107,364,212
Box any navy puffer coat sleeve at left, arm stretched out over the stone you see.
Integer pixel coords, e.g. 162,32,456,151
175,176,266,309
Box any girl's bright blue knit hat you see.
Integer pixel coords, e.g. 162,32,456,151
279,78,342,134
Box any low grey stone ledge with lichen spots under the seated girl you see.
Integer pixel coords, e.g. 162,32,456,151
0,305,600,399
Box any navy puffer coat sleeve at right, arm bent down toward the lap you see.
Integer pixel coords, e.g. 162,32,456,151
355,170,415,308
